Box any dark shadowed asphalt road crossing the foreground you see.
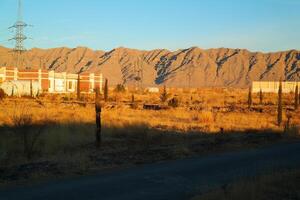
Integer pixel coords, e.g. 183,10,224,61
0,143,300,200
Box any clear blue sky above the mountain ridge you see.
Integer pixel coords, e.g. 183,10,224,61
0,0,300,51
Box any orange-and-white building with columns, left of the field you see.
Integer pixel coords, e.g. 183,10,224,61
0,67,103,93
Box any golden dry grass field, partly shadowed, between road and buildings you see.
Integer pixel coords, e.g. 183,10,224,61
0,89,300,185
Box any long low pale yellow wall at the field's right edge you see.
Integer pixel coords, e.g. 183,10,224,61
252,81,300,93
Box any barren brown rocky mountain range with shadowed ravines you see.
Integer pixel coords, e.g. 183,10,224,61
0,47,300,87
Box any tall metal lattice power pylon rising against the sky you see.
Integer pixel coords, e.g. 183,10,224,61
9,0,28,68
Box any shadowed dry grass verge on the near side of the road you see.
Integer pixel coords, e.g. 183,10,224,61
192,170,300,200
